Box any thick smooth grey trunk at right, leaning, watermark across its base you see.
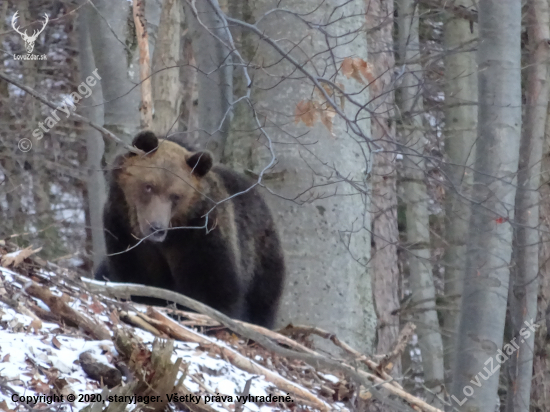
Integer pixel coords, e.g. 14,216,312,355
451,0,522,412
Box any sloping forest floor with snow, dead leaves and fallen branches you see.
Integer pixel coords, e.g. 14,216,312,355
0,241,429,412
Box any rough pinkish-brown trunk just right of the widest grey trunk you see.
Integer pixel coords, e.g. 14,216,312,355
366,0,401,377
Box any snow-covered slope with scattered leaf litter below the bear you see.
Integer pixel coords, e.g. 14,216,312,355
0,260,347,412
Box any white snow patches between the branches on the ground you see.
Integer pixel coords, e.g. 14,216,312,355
0,267,347,412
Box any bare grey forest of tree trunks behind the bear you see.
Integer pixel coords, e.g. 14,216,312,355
0,0,550,412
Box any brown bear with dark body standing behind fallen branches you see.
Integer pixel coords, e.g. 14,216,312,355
95,132,285,327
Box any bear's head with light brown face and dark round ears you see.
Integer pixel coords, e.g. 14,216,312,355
113,131,213,242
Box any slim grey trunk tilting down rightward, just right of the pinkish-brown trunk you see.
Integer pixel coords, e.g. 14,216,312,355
398,0,444,407
